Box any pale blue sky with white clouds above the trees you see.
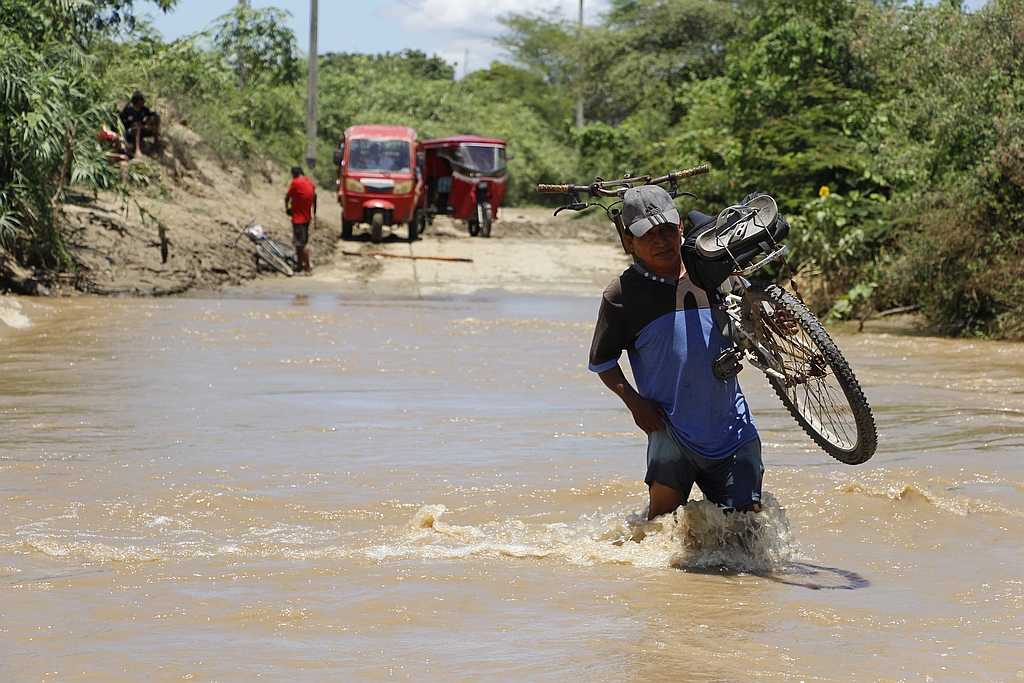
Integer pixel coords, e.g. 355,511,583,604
136,0,608,78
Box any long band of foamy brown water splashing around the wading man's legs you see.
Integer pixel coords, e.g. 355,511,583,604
8,493,799,575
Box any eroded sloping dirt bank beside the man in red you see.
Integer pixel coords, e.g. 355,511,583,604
57,125,340,296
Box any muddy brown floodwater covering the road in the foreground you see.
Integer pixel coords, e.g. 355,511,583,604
0,296,1024,683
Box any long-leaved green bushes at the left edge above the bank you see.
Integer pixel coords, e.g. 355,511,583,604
0,0,148,267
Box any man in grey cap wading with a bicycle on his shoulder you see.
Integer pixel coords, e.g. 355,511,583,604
589,185,764,519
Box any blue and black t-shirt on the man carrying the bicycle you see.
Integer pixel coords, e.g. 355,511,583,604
590,263,758,458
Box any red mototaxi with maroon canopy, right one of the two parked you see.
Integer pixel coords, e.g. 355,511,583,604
423,135,508,238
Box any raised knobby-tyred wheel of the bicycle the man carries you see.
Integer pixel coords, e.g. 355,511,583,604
743,283,878,465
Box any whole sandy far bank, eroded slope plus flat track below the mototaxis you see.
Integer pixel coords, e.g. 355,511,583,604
49,119,630,296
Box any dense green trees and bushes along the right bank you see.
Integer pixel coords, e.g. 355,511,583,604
505,0,1024,338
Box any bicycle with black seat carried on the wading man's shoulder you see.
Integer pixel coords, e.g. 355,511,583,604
538,165,878,465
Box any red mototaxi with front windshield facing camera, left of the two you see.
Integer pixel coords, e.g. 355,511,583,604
334,125,423,243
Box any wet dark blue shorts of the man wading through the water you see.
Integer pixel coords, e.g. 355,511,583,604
644,428,765,509
